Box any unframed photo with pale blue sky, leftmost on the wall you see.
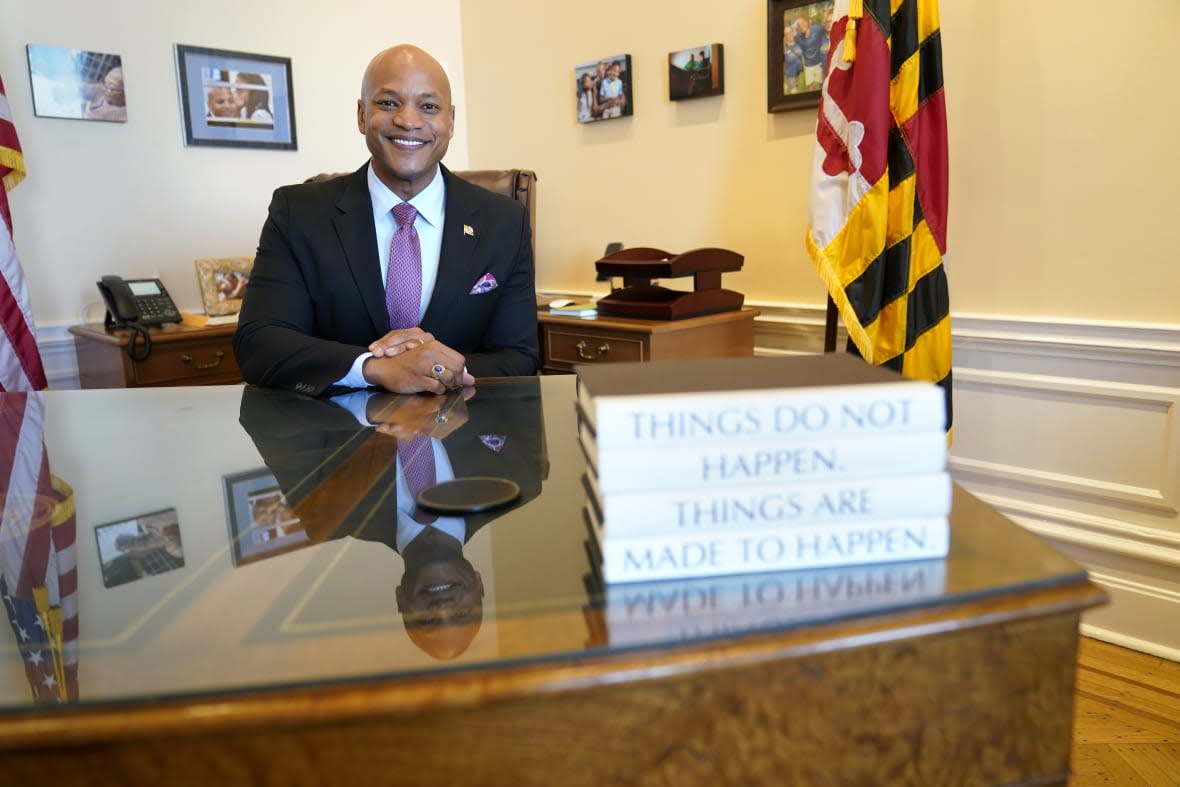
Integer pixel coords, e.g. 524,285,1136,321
25,44,127,123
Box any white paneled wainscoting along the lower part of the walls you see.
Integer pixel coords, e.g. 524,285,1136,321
38,306,1180,661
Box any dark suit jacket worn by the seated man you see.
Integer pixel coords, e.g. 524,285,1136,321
234,164,539,395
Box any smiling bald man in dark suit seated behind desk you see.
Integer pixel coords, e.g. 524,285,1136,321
234,45,539,395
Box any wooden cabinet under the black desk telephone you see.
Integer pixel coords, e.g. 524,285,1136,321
70,323,242,388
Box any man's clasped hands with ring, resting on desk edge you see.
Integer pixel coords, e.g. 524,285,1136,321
362,328,476,394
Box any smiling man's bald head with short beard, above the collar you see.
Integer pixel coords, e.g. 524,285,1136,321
356,45,454,199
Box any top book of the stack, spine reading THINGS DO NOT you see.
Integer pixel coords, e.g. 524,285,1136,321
577,353,946,448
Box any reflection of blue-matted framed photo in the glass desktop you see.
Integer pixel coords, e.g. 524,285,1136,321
223,467,312,565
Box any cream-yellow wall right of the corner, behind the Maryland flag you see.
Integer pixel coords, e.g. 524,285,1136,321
460,0,1180,322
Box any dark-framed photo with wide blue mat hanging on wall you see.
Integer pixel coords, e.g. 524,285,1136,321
176,44,296,150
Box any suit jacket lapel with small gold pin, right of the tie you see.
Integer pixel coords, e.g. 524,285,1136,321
422,166,484,324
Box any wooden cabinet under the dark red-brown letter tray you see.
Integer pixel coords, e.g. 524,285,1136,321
537,308,759,373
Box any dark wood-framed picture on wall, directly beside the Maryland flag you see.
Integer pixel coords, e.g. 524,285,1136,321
766,0,835,112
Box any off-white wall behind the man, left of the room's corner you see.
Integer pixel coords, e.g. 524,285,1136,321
0,0,466,323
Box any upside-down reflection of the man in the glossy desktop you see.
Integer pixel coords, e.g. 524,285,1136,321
241,378,545,658
